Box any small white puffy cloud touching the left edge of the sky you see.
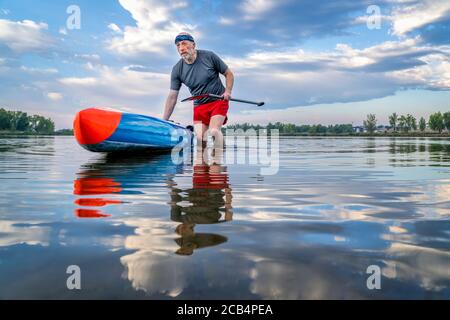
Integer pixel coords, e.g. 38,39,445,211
0,19,52,52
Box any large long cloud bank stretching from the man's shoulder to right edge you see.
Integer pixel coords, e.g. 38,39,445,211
224,38,450,107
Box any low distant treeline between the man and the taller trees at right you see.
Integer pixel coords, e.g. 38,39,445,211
227,122,354,135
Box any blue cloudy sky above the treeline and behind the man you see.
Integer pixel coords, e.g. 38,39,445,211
0,0,450,129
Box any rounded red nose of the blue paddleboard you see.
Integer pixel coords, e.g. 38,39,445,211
73,108,122,144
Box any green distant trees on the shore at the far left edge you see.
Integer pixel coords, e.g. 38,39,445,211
0,108,55,134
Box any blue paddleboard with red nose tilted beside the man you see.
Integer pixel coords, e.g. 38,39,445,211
73,108,192,152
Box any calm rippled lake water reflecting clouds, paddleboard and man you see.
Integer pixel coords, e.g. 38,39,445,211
0,137,450,299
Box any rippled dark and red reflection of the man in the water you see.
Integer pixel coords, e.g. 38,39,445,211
170,149,233,255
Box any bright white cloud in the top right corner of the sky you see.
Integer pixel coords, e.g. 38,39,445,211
391,0,450,36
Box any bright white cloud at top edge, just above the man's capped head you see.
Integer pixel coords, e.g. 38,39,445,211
107,0,198,56
